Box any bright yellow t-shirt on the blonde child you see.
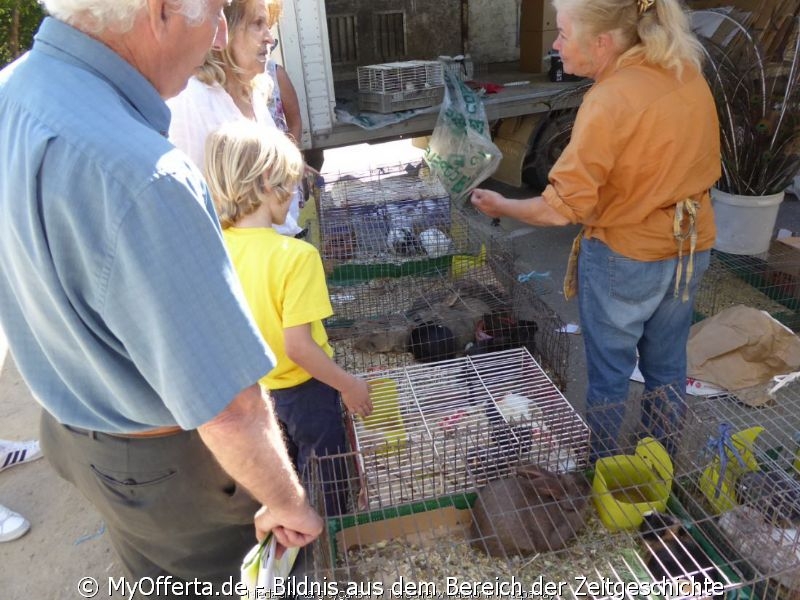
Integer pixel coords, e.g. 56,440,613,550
223,227,333,390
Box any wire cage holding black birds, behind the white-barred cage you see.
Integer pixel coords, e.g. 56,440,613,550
325,241,569,389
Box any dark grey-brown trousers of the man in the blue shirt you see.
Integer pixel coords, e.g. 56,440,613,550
41,411,260,598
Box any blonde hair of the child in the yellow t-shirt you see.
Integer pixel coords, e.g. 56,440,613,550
205,120,303,229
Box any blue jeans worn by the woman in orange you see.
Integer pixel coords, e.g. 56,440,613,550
578,239,711,458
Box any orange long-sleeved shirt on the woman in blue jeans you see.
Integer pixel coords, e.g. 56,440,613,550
542,62,721,261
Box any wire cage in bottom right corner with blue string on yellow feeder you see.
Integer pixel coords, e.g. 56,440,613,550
678,384,800,600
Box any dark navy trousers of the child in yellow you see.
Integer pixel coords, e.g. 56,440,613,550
270,378,349,517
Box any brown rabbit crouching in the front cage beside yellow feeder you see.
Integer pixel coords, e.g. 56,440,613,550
471,465,590,557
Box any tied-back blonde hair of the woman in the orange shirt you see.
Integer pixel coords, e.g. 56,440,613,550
553,0,703,77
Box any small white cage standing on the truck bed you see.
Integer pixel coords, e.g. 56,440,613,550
358,60,444,113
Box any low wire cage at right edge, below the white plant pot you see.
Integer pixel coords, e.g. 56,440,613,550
695,247,800,331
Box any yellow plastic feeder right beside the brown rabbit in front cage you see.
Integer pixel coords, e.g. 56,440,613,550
592,437,673,531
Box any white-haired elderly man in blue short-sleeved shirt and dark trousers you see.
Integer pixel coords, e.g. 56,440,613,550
0,0,322,584
